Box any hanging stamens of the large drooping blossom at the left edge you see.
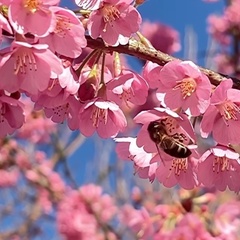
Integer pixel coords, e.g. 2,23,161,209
14,48,37,74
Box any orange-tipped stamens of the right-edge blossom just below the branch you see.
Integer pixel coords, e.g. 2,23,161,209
218,101,240,125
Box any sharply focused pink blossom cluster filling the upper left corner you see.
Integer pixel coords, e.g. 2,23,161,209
0,0,142,138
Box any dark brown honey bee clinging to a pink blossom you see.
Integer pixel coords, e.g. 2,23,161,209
147,121,192,158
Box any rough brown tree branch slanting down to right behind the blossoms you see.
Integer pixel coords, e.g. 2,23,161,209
86,36,240,90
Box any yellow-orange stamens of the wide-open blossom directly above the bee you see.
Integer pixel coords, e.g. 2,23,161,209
173,77,197,99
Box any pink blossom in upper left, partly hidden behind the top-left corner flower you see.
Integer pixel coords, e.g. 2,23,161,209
40,7,87,58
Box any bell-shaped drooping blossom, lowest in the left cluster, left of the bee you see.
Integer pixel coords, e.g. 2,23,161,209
79,98,127,138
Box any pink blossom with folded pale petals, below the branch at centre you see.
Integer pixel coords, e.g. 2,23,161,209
107,70,148,106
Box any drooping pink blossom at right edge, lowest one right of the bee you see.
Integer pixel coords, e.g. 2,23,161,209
198,146,240,192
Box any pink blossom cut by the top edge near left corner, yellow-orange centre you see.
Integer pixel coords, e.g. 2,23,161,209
8,0,60,37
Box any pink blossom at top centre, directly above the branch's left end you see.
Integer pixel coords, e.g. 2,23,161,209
88,0,141,46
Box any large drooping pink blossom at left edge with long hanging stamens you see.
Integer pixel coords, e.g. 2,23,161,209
0,42,63,94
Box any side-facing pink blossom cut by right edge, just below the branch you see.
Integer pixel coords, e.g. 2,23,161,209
200,79,240,145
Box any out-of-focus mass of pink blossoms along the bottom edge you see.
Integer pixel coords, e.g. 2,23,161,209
57,184,240,240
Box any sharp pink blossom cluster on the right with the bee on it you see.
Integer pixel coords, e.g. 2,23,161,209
115,60,240,192
